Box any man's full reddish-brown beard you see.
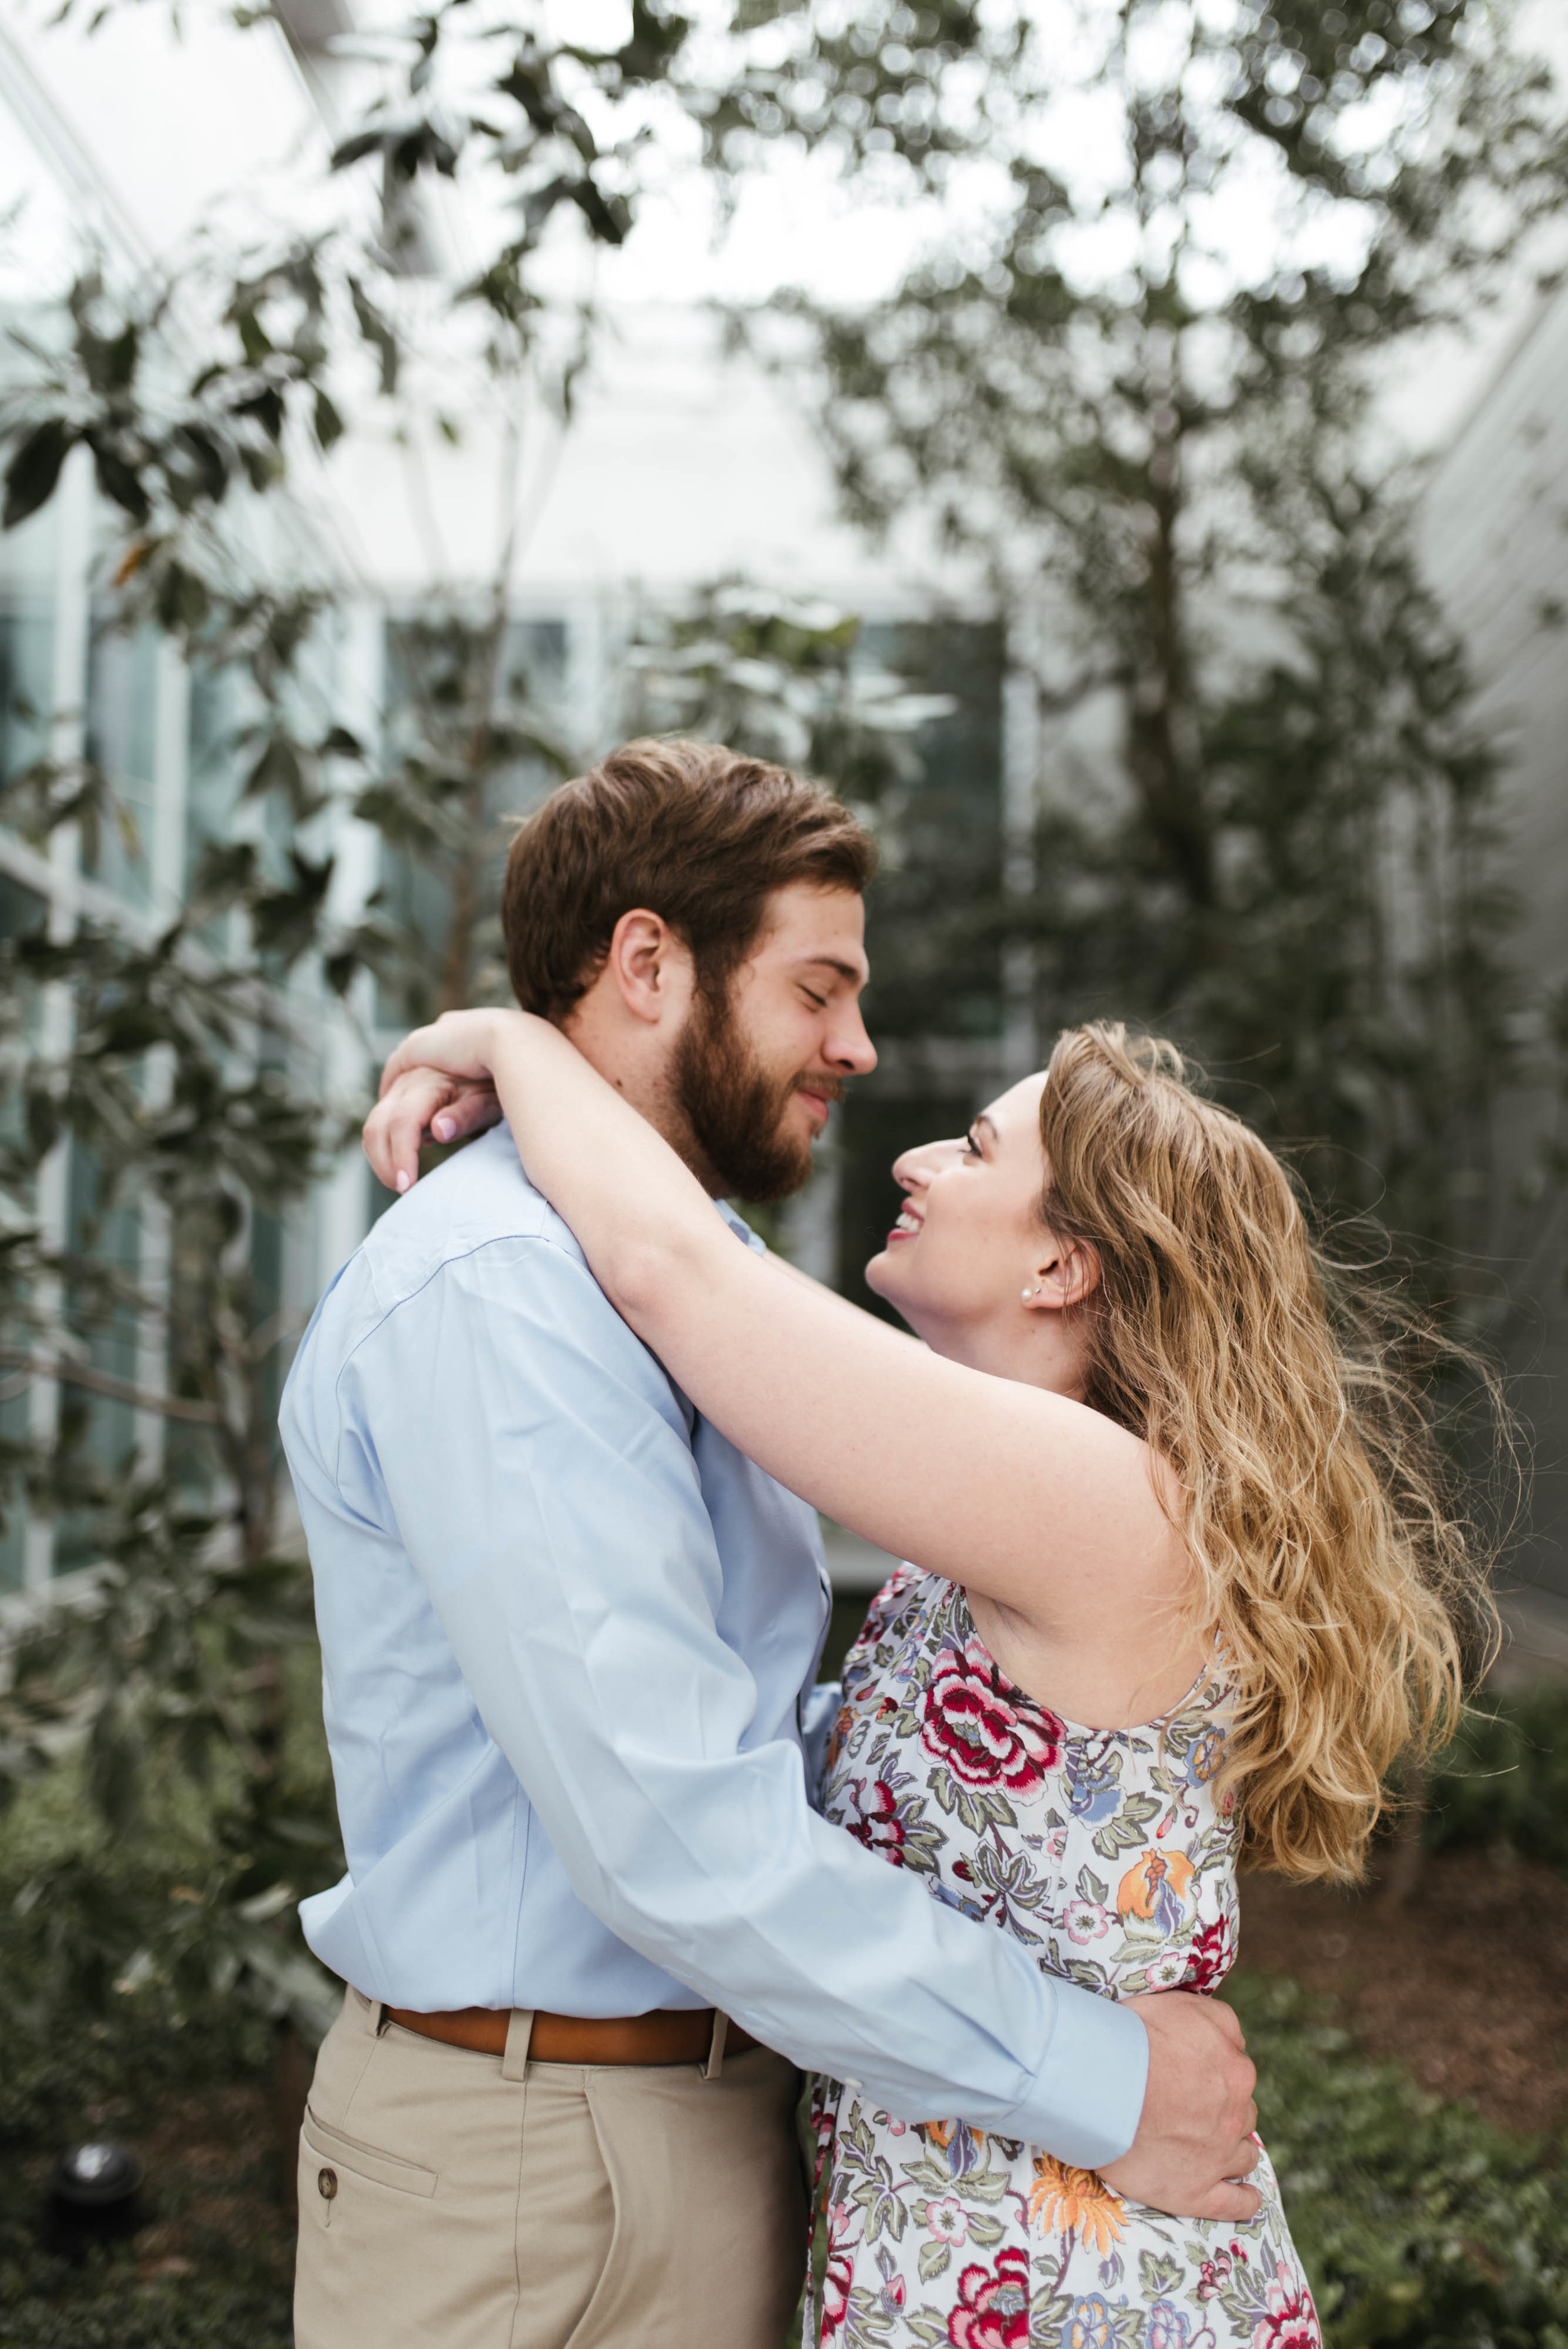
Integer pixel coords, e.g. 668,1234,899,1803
671,994,843,1202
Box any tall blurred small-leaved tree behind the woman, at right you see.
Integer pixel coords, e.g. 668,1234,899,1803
737,0,1568,1311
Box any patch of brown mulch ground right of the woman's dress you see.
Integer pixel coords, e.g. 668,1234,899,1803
1242,1851,1568,2133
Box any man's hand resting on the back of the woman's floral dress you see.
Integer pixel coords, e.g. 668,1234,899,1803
1103,1990,1261,2222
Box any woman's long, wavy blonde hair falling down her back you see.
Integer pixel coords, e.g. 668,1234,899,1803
1040,1022,1495,1879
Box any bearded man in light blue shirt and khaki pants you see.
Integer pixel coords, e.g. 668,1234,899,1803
282,742,1254,2349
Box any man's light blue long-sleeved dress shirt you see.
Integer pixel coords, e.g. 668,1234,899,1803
282,1125,1148,2166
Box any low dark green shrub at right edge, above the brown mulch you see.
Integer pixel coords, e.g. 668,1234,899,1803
1425,1680,1568,1872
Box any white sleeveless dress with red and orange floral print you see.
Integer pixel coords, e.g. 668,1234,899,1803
805,1567,1322,2349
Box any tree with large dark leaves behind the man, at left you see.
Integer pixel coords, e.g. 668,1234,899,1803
0,4,948,2032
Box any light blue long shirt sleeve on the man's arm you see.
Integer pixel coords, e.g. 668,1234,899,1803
333,1236,1148,2168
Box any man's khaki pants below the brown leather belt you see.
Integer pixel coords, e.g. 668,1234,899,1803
294,1990,805,2349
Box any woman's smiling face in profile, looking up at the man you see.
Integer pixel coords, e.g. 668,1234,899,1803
866,1073,1056,1353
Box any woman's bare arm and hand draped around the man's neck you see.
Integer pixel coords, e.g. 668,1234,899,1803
366,1012,1176,1633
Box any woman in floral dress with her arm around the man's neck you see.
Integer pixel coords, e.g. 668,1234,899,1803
361,1012,1483,2349
